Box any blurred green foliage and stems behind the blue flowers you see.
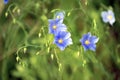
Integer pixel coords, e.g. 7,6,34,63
0,0,120,80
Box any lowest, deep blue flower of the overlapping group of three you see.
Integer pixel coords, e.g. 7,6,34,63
53,31,72,51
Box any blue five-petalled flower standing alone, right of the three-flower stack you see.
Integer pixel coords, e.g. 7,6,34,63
80,32,99,51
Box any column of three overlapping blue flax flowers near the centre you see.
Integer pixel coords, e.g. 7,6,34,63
48,12,72,51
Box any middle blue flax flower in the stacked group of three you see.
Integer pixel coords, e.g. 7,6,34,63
49,19,67,34
